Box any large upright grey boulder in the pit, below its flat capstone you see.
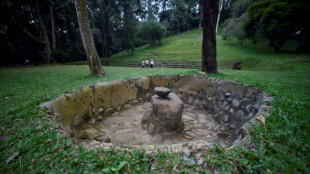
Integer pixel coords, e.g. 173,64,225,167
152,93,184,130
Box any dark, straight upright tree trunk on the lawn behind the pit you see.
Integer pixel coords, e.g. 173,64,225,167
202,0,218,73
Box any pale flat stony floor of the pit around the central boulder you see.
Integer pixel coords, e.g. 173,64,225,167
80,102,233,147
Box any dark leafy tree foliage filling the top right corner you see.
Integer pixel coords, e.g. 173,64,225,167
245,0,310,53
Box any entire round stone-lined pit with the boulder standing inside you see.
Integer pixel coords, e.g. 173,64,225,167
42,75,272,153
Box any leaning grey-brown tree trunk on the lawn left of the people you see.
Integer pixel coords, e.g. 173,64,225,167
75,0,107,76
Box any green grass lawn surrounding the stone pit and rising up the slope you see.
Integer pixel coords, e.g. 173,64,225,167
0,30,310,173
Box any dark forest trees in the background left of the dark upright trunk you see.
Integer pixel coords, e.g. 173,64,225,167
0,0,205,65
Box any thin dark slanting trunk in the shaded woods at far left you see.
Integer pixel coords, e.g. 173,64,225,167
36,2,52,63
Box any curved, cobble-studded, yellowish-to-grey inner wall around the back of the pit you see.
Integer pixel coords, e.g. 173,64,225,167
43,75,272,150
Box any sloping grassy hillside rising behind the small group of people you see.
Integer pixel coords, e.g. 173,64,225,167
103,29,309,71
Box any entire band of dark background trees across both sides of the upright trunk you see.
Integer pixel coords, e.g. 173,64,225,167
0,0,310,65
